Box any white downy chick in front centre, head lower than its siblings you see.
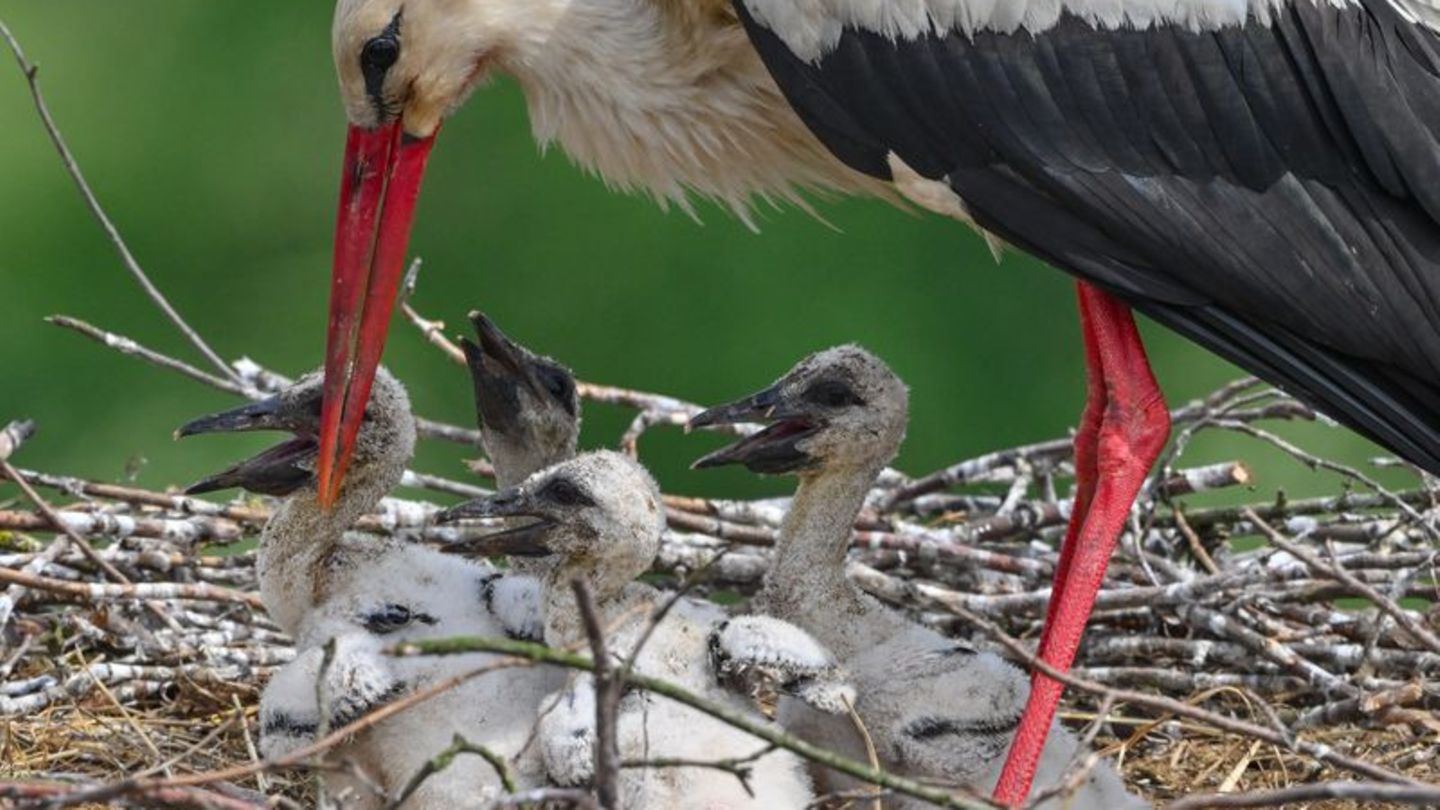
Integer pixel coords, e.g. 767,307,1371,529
442,451,829,810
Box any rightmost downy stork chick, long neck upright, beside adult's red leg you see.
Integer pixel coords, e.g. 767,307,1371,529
690,346,1143,810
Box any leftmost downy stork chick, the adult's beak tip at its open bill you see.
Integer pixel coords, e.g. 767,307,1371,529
179,372,559,809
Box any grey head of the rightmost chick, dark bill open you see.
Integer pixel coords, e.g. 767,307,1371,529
690,346,909,474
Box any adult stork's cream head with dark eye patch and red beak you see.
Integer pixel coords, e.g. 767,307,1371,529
317,0,514,506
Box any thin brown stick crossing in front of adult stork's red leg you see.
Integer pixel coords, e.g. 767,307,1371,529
953,605,1426,787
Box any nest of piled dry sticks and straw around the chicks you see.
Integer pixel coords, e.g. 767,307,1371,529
0,324,1440,807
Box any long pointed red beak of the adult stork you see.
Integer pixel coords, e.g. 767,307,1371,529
315,121,435,507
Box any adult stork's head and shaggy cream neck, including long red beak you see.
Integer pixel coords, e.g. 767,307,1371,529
318,0,881,503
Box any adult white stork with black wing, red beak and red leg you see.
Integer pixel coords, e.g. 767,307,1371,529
318,0,1440,803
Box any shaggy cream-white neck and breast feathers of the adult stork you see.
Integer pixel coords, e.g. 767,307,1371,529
498,0,883,223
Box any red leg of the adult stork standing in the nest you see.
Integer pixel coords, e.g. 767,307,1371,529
995,282,1171,806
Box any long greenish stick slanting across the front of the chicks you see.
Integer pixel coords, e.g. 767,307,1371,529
397,636,1002,810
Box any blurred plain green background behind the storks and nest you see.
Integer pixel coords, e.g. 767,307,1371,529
0,0,1399,496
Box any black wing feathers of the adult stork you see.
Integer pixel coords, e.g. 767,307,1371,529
737,0,1440,473
